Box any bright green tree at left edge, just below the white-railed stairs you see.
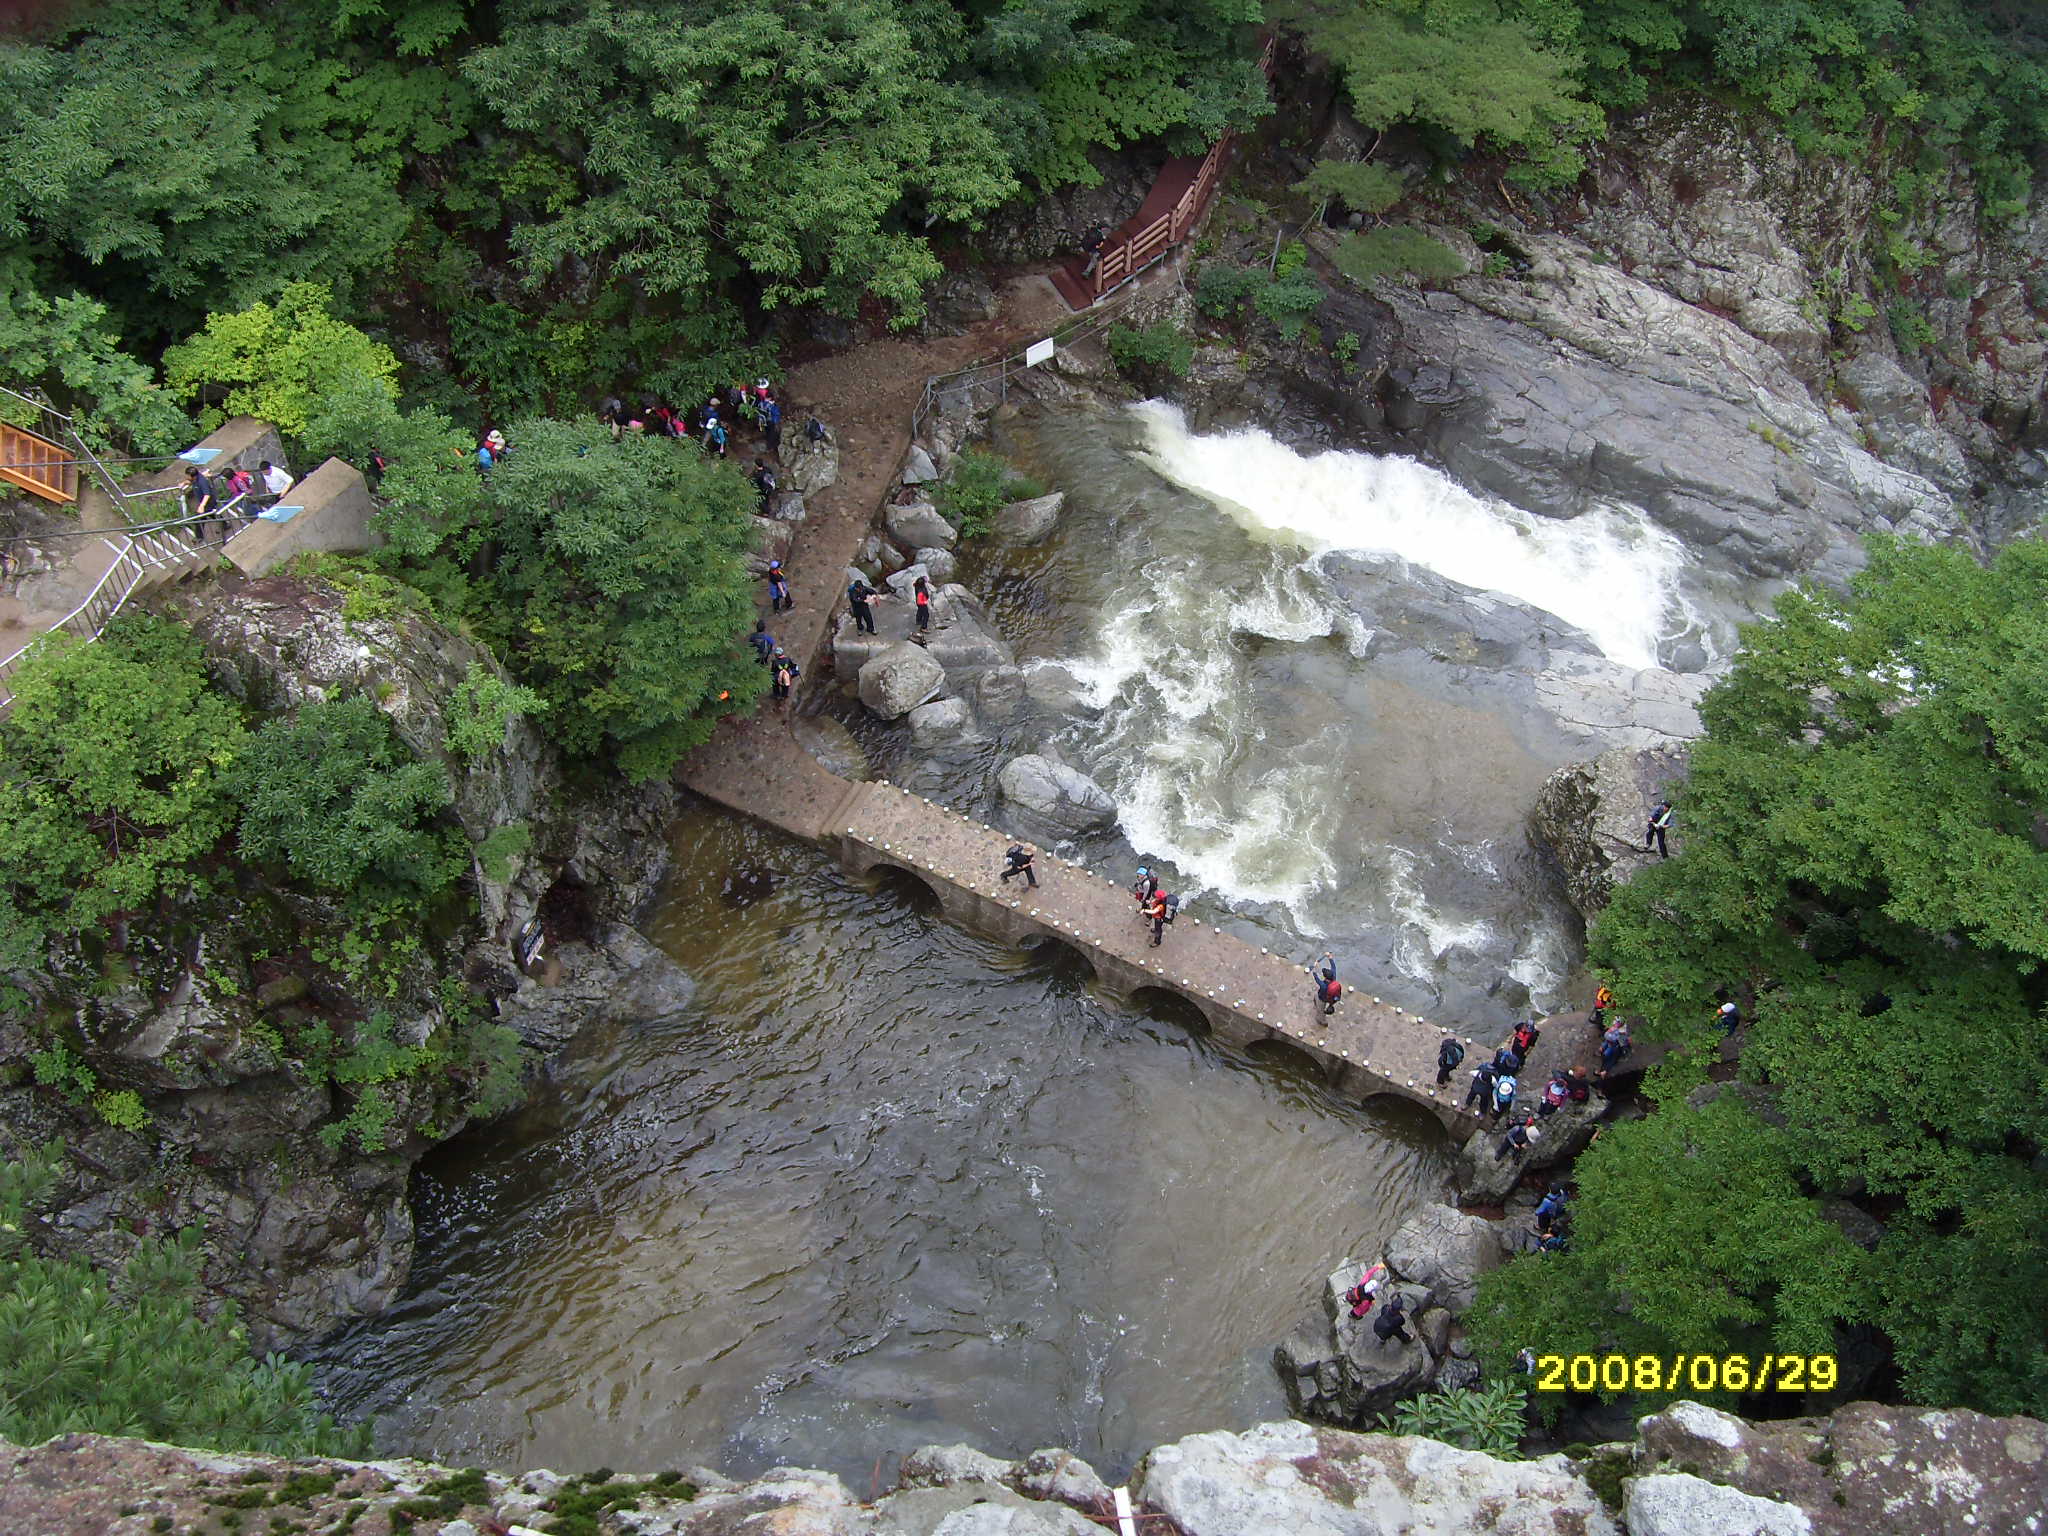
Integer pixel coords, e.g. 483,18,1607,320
0,616,246,967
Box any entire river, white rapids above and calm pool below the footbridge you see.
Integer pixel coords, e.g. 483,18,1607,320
313,408,1737,1491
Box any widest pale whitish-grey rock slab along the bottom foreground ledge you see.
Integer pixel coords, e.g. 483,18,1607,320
1133,1423,1620,1536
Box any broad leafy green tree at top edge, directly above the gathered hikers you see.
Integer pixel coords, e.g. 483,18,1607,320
465,0,1032,322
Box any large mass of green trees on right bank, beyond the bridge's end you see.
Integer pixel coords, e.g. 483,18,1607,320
1493,541,2048,1413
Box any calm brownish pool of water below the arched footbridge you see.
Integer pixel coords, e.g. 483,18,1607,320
317,809,1448,1491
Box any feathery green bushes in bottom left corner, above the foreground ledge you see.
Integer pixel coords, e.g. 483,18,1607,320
0,1147,369,1456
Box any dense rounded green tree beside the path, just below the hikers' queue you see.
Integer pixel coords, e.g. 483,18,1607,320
479,420,766,780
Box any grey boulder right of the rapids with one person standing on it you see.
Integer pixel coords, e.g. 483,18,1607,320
1530,743,1692,922
